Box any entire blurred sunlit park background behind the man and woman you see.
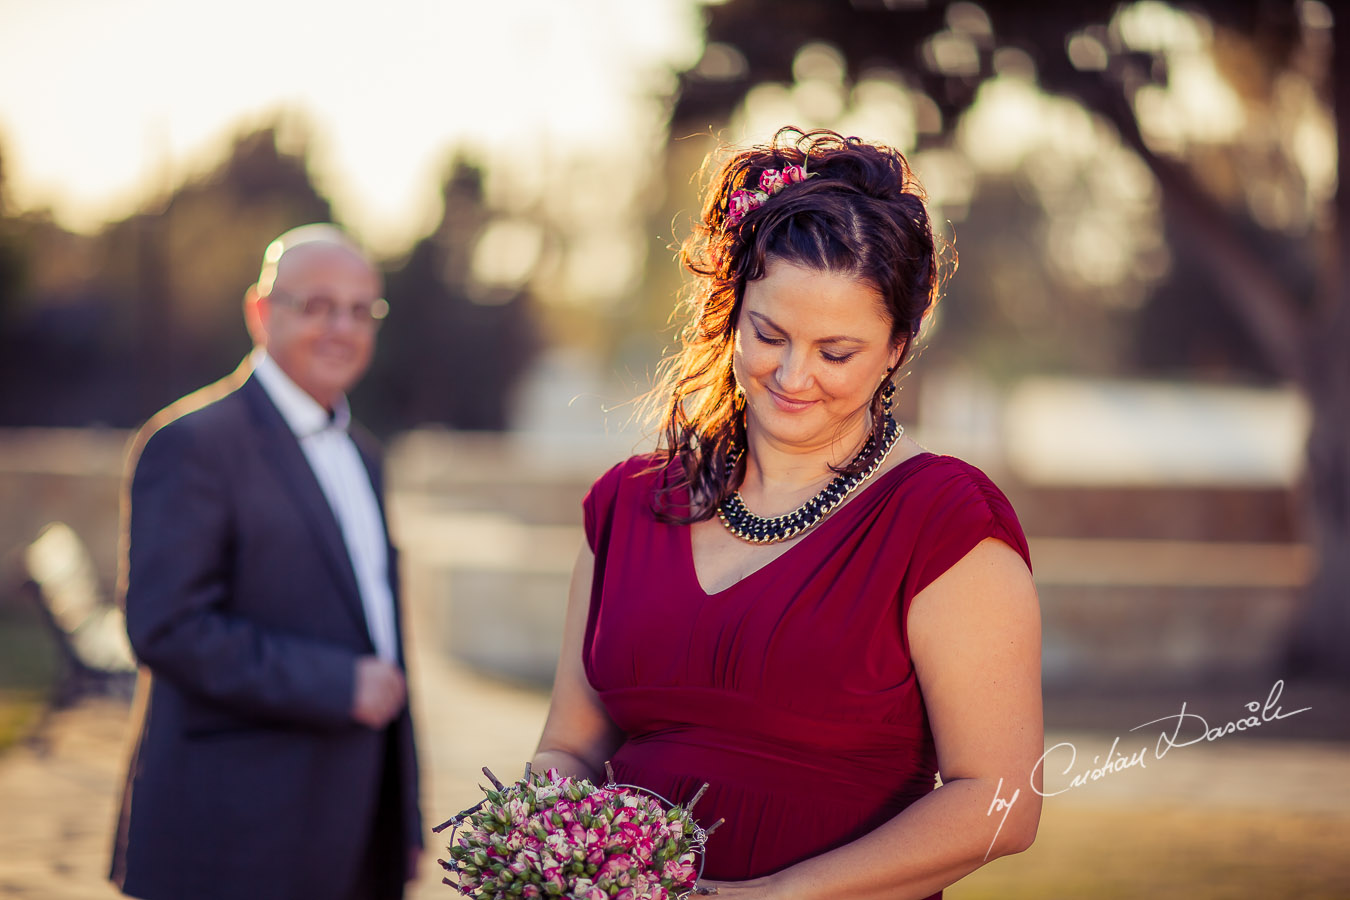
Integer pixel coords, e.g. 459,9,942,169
0,0,1350,899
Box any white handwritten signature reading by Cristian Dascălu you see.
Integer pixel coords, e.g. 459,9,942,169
984,679,1312,860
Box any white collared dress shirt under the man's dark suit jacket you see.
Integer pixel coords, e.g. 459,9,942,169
252,349,398,663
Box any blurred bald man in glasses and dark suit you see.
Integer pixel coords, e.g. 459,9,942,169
112,224,421,900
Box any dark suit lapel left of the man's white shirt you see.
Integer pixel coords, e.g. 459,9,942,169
240,378,370,641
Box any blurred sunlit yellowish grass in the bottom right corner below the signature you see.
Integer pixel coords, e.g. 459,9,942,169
944,800,1350,900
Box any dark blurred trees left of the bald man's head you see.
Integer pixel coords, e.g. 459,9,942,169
0,127,332,426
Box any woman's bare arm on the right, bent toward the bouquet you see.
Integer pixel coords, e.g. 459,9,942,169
711,538,1045,900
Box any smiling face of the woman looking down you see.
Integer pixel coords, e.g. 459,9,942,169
732,259,900,451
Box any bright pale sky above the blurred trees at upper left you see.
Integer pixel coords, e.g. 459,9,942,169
0,0,699,252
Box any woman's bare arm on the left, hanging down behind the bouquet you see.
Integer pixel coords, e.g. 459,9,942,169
533,544,624,784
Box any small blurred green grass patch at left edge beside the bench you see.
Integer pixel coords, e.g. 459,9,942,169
0,606,61,753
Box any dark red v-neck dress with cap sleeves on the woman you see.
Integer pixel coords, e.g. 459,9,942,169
582,453,1030,880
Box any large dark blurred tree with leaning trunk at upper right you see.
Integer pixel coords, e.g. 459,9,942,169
671,0,1350,676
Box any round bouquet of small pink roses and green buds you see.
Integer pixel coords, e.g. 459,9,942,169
433,764,721,900
